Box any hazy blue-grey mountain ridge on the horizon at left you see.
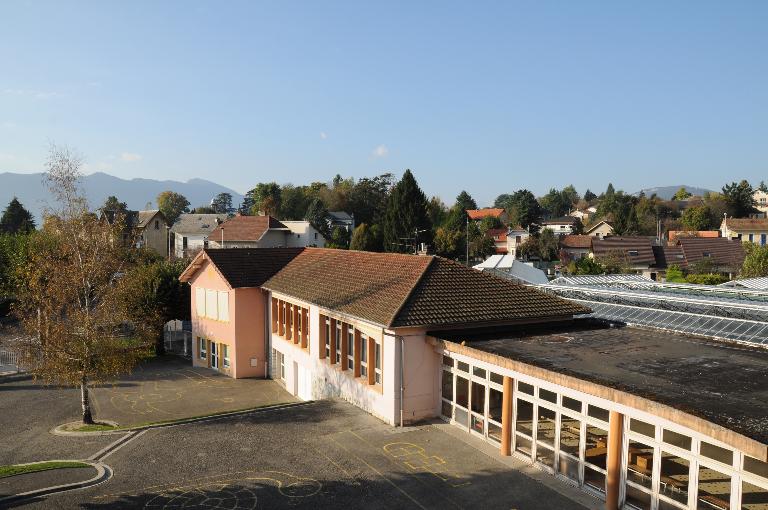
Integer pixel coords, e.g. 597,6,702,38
0,172,243,221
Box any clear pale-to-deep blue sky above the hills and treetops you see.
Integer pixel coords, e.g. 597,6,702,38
0,0,768,205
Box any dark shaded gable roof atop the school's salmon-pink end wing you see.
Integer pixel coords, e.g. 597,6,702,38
179,248,304,289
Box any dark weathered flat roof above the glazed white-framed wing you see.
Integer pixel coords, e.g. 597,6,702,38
429,319,768,444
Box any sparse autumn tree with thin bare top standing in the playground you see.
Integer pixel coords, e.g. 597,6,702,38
15,145,153,424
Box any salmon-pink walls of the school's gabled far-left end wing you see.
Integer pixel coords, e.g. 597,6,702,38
189,261,264,378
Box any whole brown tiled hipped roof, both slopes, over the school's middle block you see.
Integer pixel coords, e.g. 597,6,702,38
264,248,588,327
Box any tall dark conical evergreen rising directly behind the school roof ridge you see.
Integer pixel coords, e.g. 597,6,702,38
382,170,432,252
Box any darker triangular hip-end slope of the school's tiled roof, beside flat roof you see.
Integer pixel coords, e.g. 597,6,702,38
391,257,590,327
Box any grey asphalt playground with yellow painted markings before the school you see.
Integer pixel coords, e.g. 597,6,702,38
0,358,599,510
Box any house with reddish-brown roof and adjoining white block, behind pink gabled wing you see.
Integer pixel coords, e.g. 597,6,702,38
208,216,325,248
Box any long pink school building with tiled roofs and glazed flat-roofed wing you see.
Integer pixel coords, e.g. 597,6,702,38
181,248,768,510
